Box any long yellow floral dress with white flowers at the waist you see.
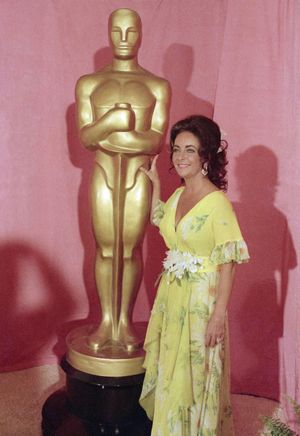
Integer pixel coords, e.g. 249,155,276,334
140,187,249,436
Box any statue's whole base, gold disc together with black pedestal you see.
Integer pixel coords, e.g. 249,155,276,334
42,326,151,436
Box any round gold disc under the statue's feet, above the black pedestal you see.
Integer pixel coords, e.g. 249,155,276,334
66,325,145,377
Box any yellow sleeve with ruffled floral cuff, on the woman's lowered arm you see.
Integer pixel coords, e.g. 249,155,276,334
210,195,250,265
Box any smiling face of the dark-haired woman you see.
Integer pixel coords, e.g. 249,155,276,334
172,131,202,179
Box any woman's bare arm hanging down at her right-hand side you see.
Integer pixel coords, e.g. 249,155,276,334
205,262,235,347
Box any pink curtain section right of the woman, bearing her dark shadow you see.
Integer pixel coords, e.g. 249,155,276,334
214,0,300,408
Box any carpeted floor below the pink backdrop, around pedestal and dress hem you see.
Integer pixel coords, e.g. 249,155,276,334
0,365,278,436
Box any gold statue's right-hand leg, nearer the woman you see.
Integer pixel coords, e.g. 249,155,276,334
118,172,151,350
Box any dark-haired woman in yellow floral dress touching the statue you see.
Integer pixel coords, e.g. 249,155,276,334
140,115,249,436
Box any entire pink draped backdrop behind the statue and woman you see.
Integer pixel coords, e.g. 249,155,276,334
0,0,300,412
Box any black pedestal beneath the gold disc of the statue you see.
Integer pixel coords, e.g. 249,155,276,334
42,359,151,436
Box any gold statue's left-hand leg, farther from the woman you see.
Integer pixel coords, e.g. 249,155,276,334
88,165,117,349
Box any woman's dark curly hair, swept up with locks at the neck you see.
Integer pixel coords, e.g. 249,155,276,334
170,115,228,191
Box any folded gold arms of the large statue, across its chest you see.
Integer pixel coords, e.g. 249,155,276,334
76,74,170,155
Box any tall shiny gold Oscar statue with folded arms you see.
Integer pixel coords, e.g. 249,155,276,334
67,9,170,375
